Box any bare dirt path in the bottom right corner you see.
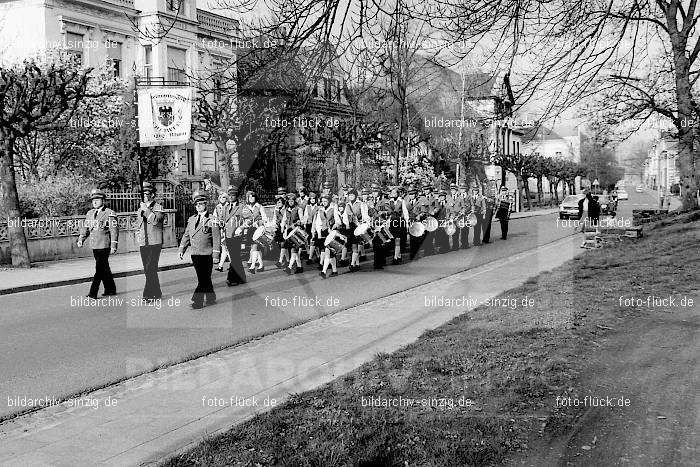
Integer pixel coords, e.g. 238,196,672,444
508,292,700,466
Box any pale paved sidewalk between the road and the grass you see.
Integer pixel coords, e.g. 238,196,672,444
0,236,580,466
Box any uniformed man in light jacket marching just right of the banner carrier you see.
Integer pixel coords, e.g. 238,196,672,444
179,191,221,309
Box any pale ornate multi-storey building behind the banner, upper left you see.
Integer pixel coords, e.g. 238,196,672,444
0,0,238,184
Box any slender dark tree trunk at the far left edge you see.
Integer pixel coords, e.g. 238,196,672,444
0,130,31,268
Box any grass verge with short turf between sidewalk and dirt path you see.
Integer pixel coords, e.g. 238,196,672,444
163,212,700,467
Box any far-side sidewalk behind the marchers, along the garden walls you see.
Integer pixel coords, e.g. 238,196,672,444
0,208,559,295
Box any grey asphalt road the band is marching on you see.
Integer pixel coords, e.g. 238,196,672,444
0,213,572,418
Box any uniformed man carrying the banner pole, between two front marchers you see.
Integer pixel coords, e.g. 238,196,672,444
136,182,165,300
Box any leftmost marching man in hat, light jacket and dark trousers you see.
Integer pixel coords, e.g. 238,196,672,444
78,188,119,299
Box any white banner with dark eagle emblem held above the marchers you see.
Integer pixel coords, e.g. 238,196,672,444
138,86,192,147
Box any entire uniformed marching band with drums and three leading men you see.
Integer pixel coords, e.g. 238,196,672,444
78,182,513,309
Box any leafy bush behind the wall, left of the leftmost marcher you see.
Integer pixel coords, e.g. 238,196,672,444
17,175,94,219
